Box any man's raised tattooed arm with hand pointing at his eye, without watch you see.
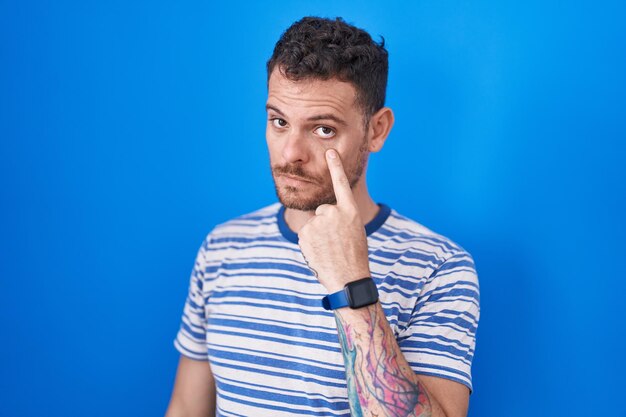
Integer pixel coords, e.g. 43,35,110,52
298,149,469,417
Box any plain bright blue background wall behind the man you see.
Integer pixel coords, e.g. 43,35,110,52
0,0,626,416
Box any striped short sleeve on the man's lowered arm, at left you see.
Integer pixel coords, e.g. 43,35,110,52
174,238,209,360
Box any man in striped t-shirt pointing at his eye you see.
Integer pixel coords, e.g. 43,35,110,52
167,18,479,417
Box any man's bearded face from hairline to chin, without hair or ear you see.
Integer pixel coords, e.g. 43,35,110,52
266,69,368,211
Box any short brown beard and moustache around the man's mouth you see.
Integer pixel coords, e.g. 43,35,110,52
271,138,368,211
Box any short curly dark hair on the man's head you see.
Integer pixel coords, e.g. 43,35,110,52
267,17,389,124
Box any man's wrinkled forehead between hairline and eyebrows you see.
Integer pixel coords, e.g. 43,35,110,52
267,69,359,116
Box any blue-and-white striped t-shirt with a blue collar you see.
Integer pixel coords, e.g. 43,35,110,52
174,203,479,417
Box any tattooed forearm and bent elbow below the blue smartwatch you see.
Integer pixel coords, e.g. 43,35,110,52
335,303,469,417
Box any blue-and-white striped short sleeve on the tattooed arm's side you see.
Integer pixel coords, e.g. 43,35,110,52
398,252,480,391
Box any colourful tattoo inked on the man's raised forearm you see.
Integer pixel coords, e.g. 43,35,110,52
335,305,431,417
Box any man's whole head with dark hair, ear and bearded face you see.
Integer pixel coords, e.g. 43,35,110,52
266,17,393,211
